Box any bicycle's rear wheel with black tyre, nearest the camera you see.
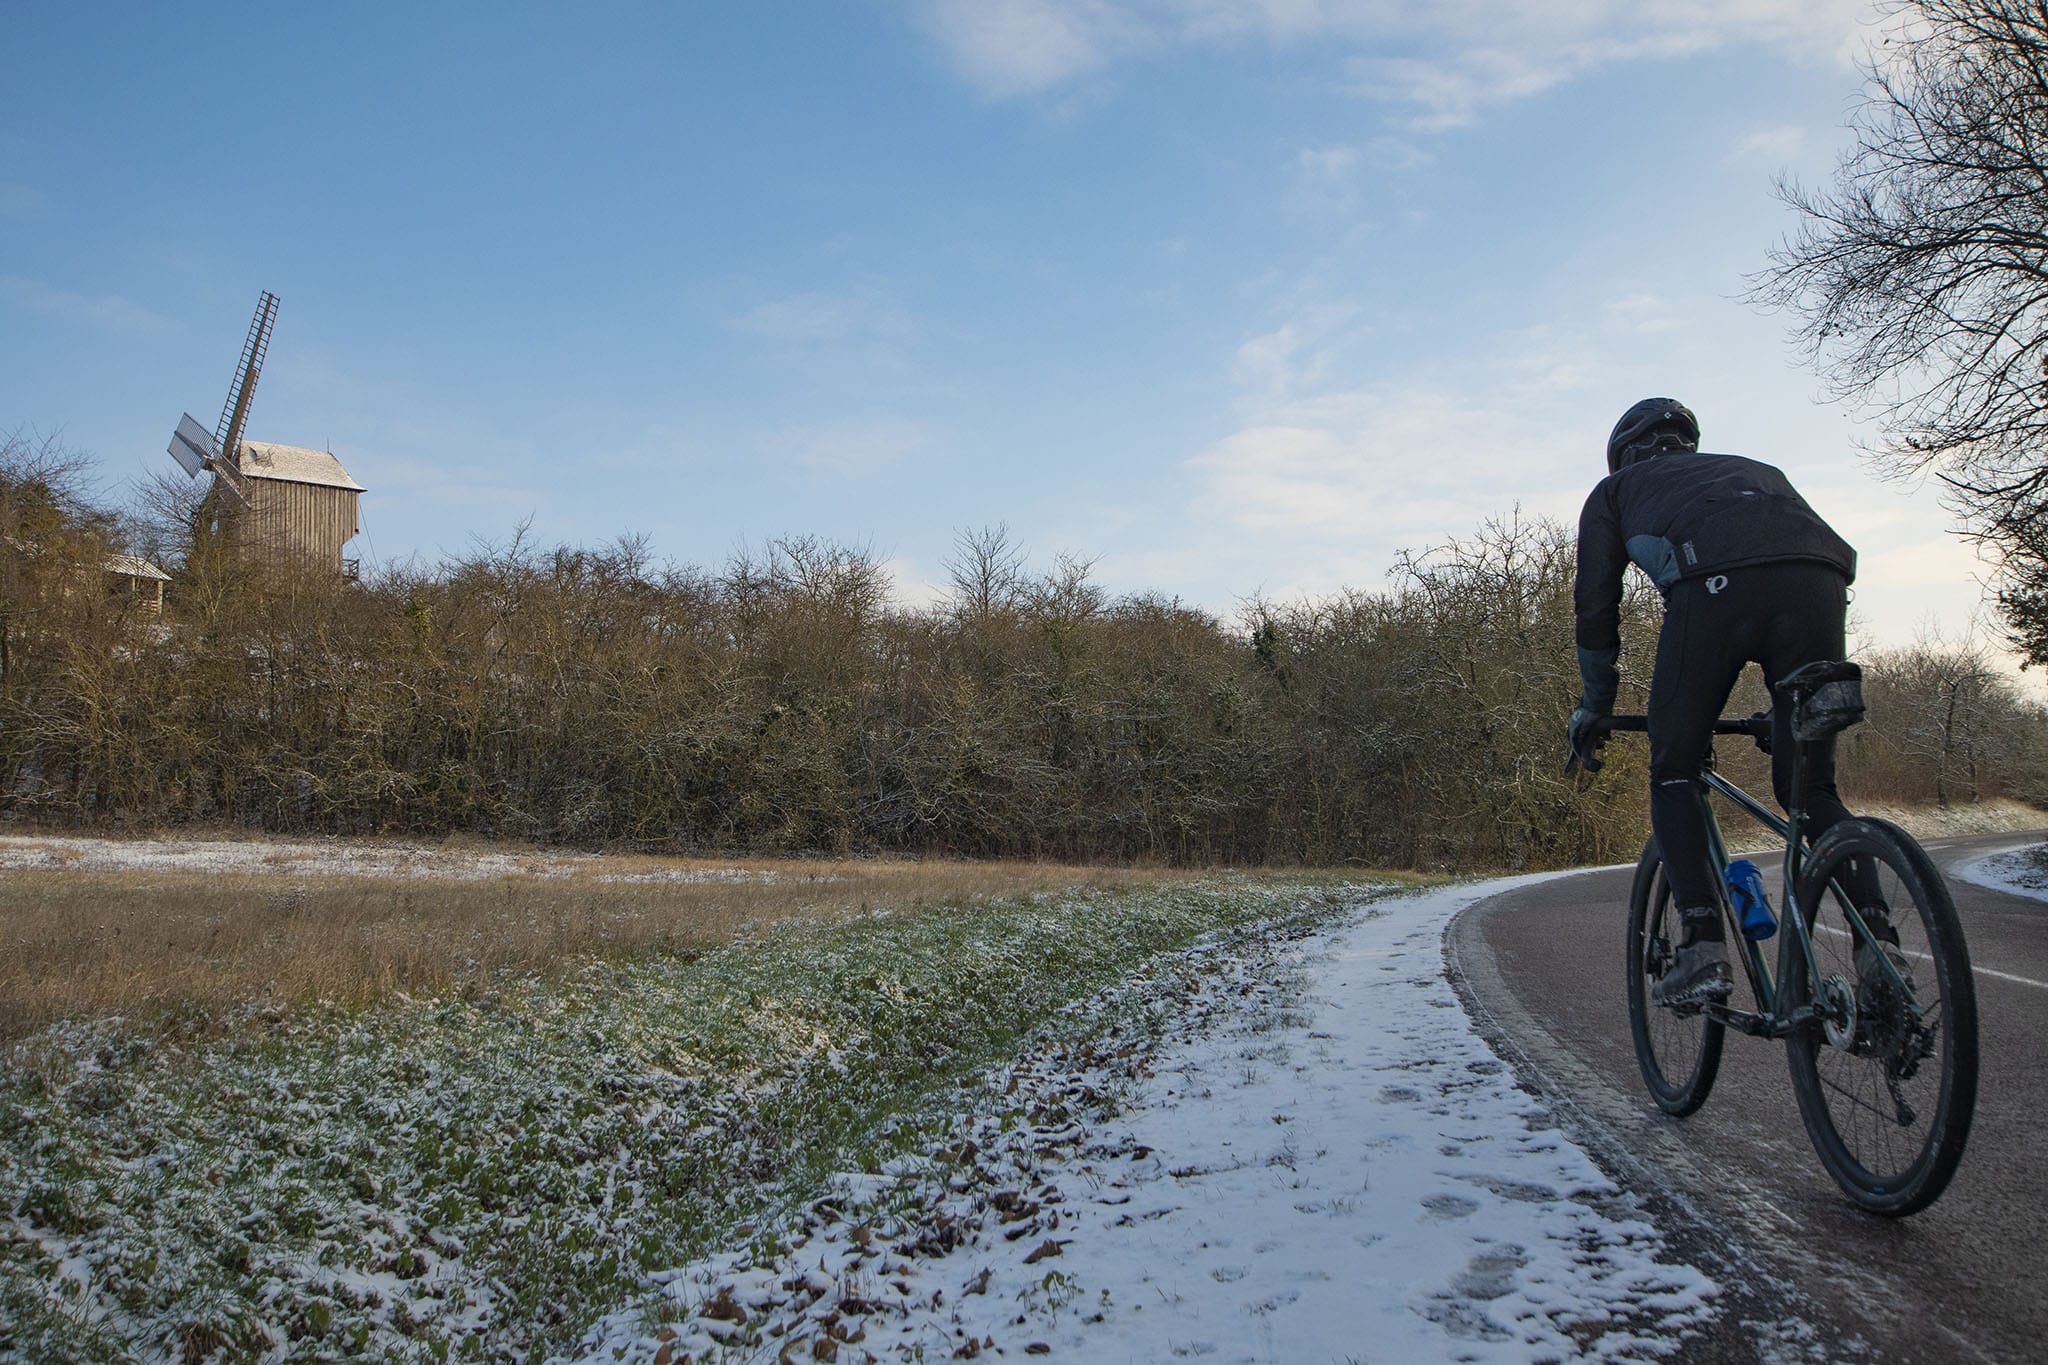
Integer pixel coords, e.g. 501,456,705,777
1780,819,1976,1218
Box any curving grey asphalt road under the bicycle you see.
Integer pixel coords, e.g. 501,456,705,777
1446,835,2048,1363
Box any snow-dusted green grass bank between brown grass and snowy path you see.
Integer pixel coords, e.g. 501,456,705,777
0,880,1392,1361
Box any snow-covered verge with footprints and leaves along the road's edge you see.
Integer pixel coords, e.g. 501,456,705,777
580,882,1716,1365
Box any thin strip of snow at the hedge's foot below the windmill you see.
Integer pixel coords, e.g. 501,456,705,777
0,835,776,882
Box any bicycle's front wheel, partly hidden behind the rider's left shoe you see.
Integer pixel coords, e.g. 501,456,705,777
1628,837,1726,1117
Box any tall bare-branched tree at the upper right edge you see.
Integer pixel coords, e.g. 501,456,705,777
1751,0,2048,663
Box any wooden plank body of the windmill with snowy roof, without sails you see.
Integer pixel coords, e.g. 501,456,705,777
209,440,362,573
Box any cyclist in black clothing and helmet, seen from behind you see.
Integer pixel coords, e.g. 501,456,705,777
1569,399,1896,1005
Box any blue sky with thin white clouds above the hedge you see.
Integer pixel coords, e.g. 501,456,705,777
0,0,1980,658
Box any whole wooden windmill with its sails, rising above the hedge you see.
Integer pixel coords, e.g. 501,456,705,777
170,291,362,573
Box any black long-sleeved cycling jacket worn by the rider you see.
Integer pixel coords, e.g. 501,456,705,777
1573,450,1855,710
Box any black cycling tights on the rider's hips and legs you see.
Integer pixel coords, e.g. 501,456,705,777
1651,563,1876,925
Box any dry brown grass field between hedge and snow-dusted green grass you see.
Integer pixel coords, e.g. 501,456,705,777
0,857,1171,1038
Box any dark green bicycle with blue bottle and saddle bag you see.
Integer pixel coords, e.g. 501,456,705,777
1567,663,1976,1218
